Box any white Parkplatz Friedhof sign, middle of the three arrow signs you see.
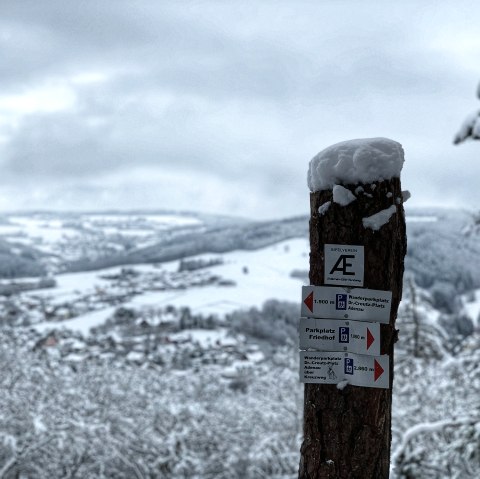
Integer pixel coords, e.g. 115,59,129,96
298,318,380,356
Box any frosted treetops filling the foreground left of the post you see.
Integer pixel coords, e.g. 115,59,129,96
0,329,300,479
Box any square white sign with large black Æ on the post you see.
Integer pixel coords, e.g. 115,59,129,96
324,244,364,288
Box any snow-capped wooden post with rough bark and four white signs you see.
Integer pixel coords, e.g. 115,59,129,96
299,138,407,479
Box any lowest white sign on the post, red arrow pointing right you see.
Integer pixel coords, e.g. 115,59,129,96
300,351,390,389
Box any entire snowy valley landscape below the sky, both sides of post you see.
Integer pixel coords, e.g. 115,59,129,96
0,209,480,479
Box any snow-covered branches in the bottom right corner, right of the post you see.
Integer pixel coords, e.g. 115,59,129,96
392,334,480,479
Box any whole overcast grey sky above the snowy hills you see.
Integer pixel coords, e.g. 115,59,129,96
0,0,480,218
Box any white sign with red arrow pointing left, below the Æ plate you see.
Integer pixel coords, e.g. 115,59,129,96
301,286,392,324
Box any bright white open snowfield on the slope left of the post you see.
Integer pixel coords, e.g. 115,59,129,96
24,239,308,333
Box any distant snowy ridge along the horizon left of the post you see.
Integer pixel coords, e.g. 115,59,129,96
0,212,308,277
